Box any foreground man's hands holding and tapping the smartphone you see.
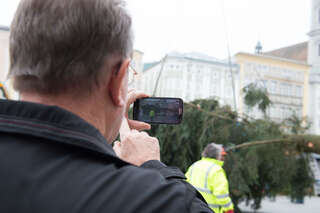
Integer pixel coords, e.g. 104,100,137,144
113,90,160,166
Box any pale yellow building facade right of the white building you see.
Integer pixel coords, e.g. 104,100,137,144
235,50,310,122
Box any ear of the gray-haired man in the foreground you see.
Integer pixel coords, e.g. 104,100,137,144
109,59,130,107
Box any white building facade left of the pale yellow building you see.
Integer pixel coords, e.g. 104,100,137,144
135,53,240,107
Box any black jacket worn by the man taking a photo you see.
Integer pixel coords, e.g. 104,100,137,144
0,101,212,213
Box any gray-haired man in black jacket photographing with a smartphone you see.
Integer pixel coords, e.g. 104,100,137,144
0,0,212,213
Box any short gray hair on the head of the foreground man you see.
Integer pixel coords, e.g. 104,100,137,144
8,0,133,94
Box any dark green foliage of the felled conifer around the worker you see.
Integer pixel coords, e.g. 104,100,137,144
151,95,312,212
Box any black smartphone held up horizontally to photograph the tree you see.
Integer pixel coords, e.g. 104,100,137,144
133,97,183,124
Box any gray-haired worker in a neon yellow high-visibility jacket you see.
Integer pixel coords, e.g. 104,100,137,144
186,143,234,213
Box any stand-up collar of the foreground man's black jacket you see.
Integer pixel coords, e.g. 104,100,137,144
0,100,116,157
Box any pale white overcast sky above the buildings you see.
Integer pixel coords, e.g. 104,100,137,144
0,0,311,61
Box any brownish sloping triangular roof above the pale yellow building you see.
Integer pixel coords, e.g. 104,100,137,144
263,41,308,63
